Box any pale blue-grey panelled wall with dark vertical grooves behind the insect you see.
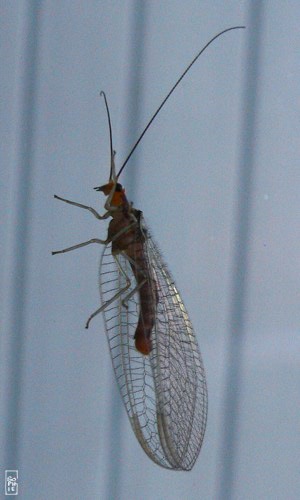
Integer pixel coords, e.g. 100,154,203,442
0,0,300,500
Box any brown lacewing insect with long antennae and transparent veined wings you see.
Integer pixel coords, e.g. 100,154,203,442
52,26,243,470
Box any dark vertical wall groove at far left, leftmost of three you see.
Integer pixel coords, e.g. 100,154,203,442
4,0,42,469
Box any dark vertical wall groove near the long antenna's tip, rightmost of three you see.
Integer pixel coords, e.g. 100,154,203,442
217,1,263,500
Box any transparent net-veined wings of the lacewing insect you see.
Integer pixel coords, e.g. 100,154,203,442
100,223,207,470
